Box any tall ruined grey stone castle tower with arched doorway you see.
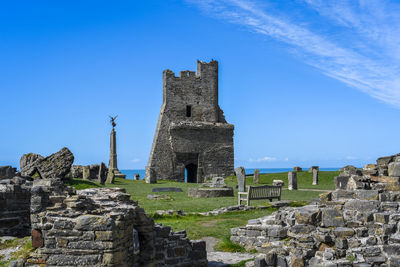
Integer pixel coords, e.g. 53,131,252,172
146,60,234,183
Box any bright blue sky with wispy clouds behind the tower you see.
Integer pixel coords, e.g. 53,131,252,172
0,0,400,169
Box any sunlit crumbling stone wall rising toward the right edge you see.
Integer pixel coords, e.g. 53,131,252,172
231,155,400,267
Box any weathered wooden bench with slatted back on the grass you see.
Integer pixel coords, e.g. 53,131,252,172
238,185,282,206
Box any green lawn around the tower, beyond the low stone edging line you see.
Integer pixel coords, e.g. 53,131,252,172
69,172,338,214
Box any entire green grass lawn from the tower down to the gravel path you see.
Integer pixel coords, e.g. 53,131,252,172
68,172,339,255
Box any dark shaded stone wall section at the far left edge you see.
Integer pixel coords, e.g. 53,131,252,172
0,177,31,237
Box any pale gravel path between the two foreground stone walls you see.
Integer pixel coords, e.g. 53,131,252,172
202,237,256,267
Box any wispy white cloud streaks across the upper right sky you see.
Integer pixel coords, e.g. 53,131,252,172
188,0,400,108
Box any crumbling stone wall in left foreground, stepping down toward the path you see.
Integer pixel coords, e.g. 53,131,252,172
26,179,207,266
